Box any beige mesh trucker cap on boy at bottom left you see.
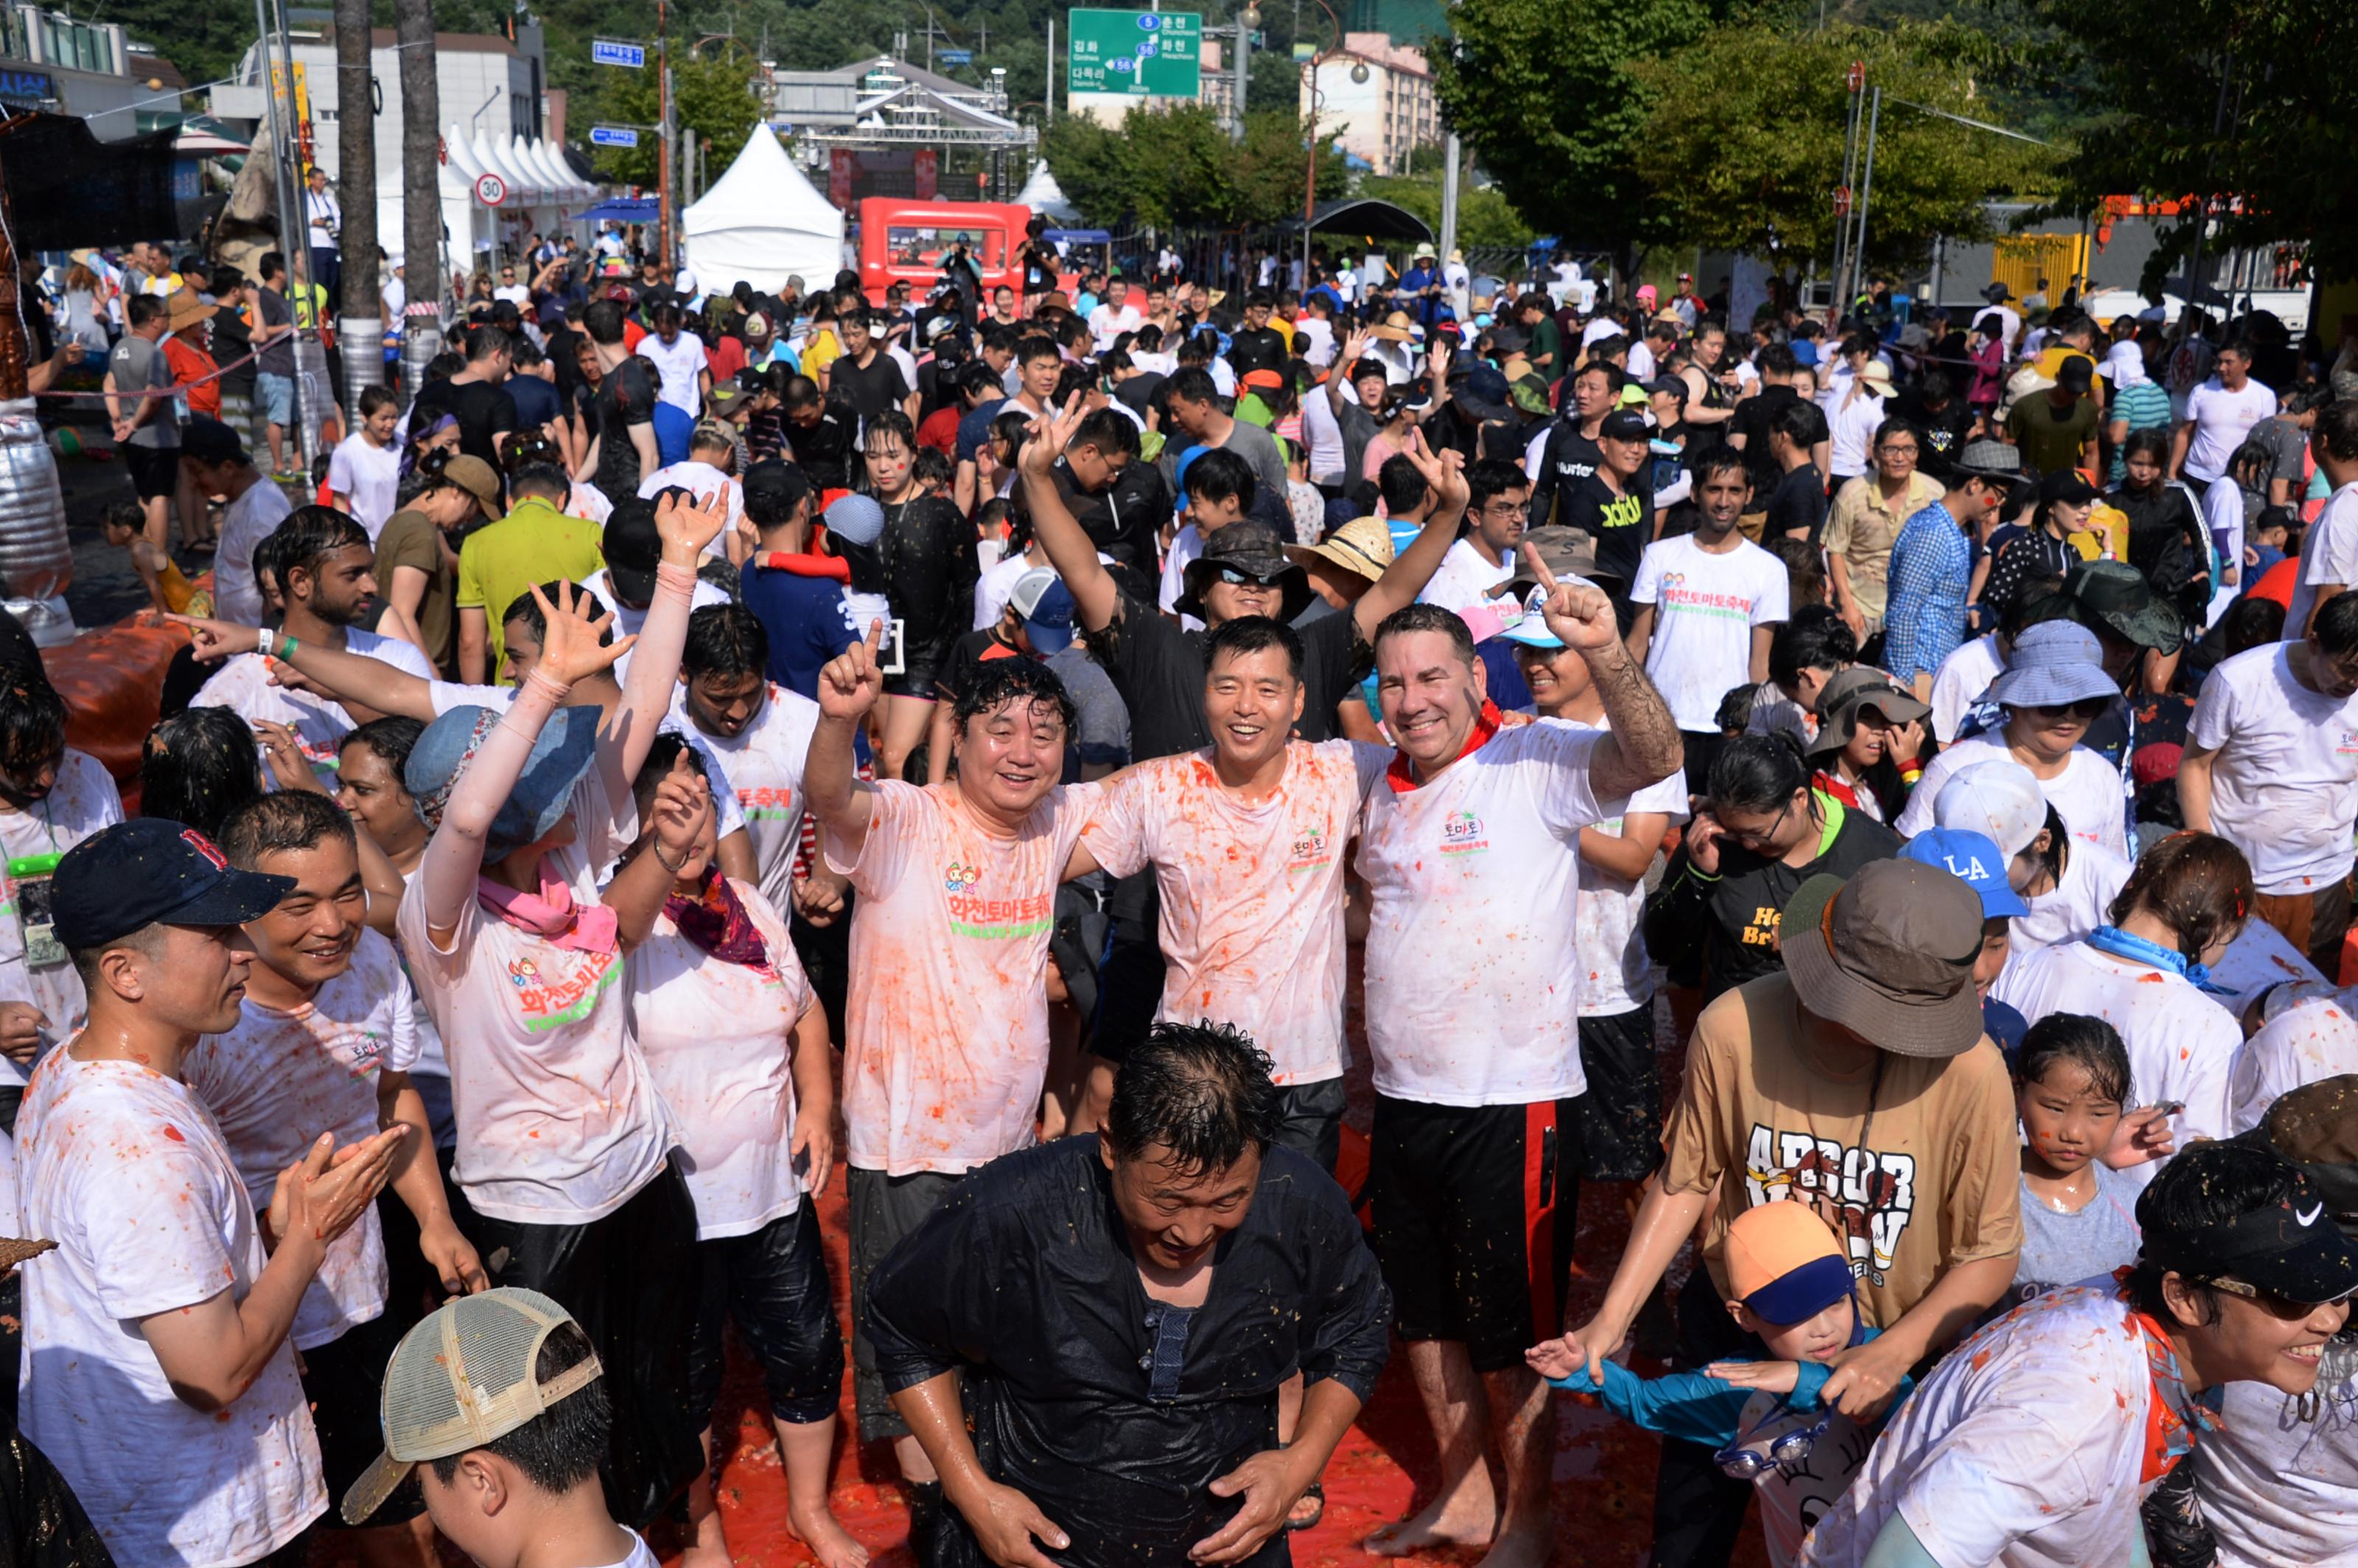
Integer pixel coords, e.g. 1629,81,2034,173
342,1287,604,1525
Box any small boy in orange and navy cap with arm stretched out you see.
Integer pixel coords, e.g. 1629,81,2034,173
1525,1203,1910,1568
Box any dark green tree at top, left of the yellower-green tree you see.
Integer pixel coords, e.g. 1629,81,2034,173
1427,0,1710,257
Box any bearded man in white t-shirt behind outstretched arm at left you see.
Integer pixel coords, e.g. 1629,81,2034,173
191,507,436,788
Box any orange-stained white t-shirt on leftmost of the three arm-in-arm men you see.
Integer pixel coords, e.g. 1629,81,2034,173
821,783,1096,1177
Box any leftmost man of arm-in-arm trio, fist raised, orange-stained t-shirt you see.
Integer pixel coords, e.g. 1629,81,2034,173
802,629,1094,1507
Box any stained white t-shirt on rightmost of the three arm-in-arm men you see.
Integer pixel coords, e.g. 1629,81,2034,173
1358,724,1629,1106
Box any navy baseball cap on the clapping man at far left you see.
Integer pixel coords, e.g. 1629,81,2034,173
49,816,295,953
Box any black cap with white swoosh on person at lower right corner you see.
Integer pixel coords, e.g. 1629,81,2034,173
2136,1139,2358,1306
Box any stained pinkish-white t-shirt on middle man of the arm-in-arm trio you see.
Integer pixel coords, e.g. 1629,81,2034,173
1080,741,1391,1085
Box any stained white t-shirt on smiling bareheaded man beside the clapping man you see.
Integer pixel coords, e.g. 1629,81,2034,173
179,931,417,1351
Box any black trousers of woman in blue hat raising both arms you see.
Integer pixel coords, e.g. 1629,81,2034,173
462,1165,710,1530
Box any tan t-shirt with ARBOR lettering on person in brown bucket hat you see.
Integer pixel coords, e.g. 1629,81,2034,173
1662,974,2023,1328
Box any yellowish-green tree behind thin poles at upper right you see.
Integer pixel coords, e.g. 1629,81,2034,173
1634,24,2051,264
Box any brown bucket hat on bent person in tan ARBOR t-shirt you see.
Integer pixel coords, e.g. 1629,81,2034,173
1778,861,1981,1059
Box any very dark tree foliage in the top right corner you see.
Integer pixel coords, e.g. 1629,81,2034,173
2054,0,2358,287
